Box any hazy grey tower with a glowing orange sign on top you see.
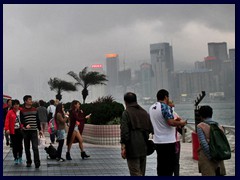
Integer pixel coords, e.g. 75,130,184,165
106,54,119,96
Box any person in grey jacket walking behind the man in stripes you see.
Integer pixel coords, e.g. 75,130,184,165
37,100,48,138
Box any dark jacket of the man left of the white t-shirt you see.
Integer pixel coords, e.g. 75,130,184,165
120,103,153,159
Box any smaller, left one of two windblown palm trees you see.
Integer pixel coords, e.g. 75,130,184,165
48,77,77,101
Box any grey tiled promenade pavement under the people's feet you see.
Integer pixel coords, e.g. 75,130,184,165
3,138,235,176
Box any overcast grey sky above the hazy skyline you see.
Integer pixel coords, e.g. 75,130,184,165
3,4,235,102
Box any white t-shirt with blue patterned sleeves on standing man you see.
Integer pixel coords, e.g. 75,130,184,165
149,102,176,144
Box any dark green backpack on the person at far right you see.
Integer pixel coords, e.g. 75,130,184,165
209,124,231,161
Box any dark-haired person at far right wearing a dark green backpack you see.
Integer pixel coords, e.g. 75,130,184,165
197,106,226,176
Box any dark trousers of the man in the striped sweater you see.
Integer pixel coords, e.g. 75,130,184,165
23,130,40,165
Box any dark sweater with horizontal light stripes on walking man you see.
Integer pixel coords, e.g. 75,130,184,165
20,107,41,131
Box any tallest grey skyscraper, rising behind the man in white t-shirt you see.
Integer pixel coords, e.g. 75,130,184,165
150,43,174,94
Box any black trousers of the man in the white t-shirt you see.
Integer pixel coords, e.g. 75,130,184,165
156,143,176,176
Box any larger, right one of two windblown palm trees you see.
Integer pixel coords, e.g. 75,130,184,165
67,67,108,104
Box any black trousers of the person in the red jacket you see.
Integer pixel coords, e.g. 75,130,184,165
10,129,23,159
